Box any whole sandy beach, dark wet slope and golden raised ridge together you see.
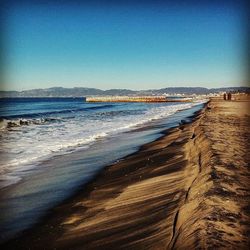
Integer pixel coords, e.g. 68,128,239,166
2,95,250,249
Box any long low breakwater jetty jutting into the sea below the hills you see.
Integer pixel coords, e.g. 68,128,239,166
86,96,190,102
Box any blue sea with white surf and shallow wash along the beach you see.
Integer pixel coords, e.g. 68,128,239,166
0,98,206,241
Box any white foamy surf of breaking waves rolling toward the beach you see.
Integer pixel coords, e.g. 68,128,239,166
0,102,205,186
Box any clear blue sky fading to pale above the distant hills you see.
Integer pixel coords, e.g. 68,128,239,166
2,1,245,90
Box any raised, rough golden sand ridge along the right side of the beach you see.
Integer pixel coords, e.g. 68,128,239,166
171,99,250,249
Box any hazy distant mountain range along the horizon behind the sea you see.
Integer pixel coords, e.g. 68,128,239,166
0,87,250,97
